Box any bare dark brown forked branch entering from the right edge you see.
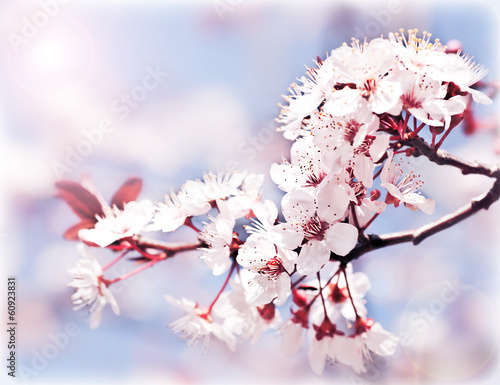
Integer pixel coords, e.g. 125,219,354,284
330,137,500,263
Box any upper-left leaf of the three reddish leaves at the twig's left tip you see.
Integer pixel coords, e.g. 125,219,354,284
56,180,104,222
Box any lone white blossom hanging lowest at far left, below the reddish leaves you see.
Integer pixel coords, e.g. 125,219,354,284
68,244,120,329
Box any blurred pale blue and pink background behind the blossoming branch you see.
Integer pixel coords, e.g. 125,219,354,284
0,0,500,384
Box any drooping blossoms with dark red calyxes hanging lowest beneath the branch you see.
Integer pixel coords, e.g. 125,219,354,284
281,263,398,374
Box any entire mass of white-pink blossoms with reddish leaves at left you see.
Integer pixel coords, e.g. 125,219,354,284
57,30,491,374
